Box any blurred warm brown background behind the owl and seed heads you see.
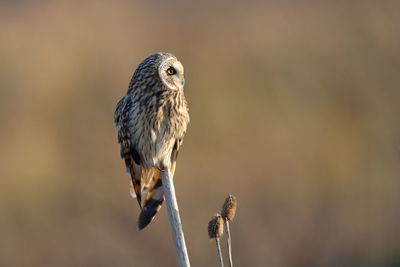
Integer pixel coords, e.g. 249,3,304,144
0,0,400,267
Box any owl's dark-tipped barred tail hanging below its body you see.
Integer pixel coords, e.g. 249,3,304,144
137,177,164,230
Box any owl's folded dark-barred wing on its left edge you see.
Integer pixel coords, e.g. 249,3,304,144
114,96,142,207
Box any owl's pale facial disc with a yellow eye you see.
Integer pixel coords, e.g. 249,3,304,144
158,57,185,90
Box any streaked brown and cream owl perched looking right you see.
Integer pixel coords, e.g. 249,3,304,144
114,52,189,230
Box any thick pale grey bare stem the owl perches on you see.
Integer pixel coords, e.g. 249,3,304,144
161,170,190,267
